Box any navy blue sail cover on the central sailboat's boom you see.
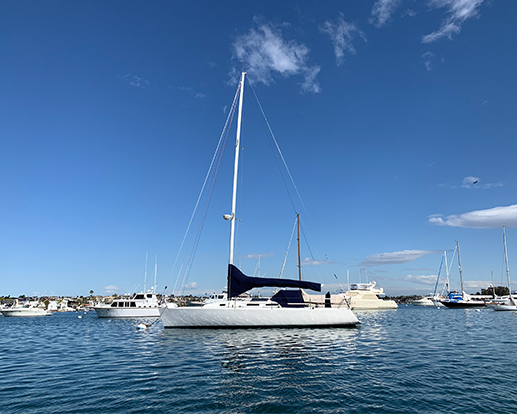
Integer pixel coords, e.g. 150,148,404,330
228,265,321,298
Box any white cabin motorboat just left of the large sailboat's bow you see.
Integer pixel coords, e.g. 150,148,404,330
93,292,160,318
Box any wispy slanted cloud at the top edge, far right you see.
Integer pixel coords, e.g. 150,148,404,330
422,0,484,43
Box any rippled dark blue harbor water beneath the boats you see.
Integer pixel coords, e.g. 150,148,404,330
0,306,517,414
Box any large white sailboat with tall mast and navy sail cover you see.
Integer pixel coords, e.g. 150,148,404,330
161,72,359,328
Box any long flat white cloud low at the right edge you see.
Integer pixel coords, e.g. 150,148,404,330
429,204,517,229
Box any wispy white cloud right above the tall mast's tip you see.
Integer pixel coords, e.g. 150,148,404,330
233,19,321,93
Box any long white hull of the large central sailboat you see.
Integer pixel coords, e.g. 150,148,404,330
162,307,359,328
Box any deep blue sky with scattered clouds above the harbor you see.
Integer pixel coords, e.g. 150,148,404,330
0,0,517,296
